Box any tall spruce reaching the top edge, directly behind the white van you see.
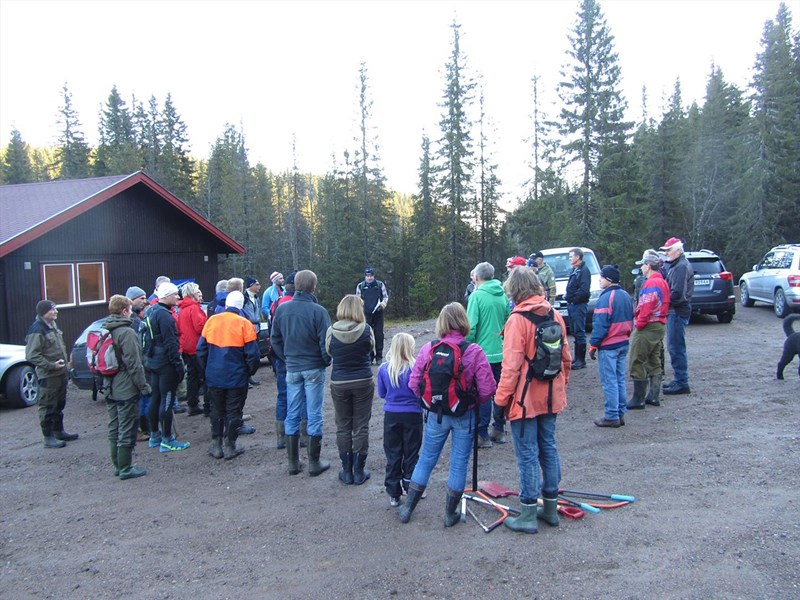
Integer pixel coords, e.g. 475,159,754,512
559,0,631,244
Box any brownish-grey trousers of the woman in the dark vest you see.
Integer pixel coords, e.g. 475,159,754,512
331,379,375,455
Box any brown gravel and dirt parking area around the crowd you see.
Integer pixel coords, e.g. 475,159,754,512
0,307,800,600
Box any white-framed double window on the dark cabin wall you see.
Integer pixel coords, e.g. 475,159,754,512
42,262,108,307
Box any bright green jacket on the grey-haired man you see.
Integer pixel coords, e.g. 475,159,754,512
466,279,511,364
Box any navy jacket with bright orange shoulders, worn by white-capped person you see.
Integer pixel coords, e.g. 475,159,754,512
197,307,260,389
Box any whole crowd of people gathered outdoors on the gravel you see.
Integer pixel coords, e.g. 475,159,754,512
26,238,693,533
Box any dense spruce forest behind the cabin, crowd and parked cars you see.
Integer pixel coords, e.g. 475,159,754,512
0,0,800,318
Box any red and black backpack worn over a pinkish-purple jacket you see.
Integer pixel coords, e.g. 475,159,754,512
419,340,477,423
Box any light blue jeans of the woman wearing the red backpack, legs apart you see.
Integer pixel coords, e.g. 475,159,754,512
411,410,475,492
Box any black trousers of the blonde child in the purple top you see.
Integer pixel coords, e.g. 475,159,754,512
383,412,422,498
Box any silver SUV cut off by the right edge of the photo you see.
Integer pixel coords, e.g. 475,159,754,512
739,244,800,319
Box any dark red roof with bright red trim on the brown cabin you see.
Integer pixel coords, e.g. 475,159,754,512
0,171,245,257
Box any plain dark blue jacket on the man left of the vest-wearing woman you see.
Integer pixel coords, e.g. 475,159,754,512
268,291,331,373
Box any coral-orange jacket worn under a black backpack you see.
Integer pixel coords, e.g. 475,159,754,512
494,296,572,421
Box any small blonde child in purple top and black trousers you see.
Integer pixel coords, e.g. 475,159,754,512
378,333,422,506
